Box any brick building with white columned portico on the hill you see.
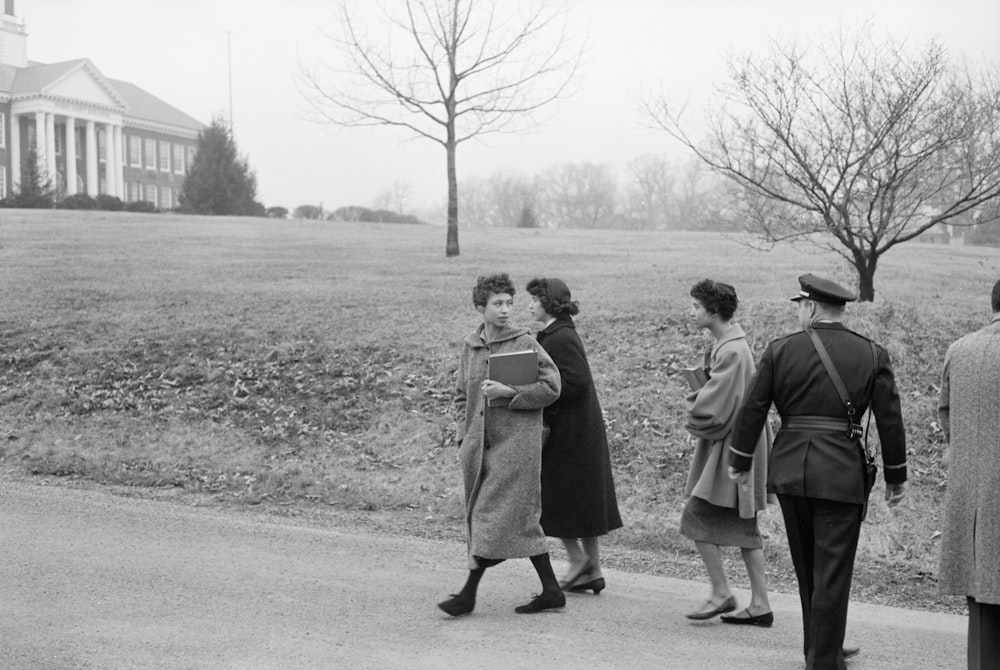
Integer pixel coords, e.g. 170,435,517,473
0,0,204,209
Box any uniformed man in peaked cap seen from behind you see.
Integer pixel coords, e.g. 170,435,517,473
729,274,906,670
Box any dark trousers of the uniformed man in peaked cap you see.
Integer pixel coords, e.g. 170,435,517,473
778,495,863,670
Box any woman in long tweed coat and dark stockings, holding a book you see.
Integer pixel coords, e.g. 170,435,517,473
438,273,566,616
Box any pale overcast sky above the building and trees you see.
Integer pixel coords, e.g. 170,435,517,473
16,0,1000,214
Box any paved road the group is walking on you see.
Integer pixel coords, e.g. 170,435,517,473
0,477,966,670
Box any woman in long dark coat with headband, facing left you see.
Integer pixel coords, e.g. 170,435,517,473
527,278,622,595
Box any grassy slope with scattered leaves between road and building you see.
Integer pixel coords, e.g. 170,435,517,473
0,210,1000,609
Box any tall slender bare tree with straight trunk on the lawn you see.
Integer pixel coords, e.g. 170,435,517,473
302,0,581,256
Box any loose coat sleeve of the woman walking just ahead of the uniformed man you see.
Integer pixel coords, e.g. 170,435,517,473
684,346,744,444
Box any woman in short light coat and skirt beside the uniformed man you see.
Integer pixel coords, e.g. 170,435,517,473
680,279,774,627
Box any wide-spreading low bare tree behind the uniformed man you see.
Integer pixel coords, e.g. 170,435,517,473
645,26,1000,301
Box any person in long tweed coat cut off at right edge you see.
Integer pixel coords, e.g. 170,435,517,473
938,281,1000,670
